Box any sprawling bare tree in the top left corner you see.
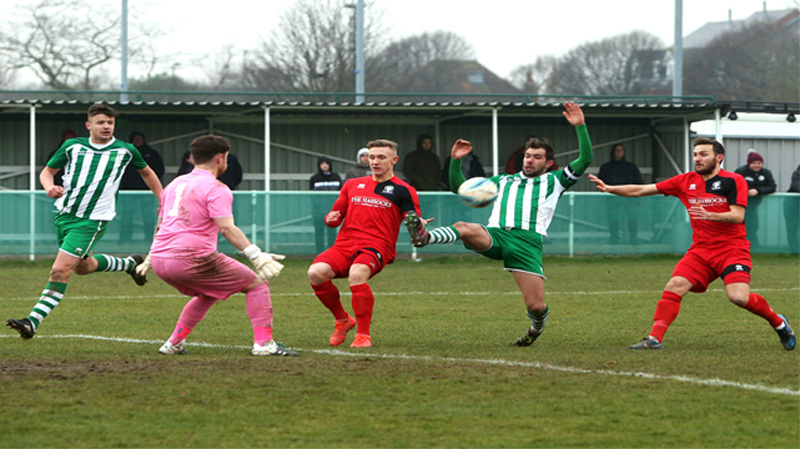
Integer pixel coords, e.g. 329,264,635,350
0,0,162,90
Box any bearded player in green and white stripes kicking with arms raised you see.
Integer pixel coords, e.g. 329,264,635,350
412,102,592,346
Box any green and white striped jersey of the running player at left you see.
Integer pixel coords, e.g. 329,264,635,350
47,137,147,221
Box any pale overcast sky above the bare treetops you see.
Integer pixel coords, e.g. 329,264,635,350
0,0,800,85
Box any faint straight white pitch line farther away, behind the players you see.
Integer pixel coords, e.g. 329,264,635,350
0,287,800,301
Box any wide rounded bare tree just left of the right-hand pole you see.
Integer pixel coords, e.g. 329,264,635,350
550,31,664,95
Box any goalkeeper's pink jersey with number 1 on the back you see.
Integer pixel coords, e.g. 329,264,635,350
150,169,233,257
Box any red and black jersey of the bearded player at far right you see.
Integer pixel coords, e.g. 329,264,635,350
656,170,749,248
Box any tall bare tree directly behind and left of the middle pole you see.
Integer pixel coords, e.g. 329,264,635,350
245,0,384,92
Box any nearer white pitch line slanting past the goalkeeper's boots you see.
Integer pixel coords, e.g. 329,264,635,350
0,334,800,396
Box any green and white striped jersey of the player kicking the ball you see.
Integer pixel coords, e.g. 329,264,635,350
487,165,578,237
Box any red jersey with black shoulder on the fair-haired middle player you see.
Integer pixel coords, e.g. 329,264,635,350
331,176,422,263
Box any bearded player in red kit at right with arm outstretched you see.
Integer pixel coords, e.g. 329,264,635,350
589,137,796,351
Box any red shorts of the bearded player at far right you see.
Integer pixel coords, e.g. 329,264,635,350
672,243,753,293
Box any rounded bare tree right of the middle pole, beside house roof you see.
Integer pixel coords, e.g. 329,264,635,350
366,31,475,92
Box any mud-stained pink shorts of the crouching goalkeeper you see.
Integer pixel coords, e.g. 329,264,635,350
152,253,256,299
